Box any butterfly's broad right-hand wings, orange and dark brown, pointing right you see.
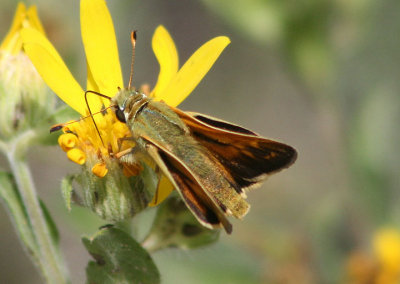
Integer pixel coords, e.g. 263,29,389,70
172,108,297,191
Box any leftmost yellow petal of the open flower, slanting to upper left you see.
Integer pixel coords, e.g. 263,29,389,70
21,28,90,115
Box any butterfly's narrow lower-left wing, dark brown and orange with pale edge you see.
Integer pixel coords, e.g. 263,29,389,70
142,137,232,234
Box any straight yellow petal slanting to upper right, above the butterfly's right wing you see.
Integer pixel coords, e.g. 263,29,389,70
157,36,230,106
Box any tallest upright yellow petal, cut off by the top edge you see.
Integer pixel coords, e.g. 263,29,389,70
81,0,124,97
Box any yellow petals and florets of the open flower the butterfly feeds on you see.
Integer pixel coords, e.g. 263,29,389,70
21,0,230,205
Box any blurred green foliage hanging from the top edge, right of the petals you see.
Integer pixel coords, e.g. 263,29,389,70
203,0,372,96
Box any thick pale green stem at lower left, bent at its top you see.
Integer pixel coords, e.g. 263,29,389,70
7,131,68,283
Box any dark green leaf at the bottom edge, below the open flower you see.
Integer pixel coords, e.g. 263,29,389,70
82,227,160,284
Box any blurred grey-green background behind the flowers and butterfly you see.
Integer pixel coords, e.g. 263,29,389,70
0,0,400,284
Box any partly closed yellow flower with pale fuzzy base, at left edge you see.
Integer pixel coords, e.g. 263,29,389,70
0,3,54,139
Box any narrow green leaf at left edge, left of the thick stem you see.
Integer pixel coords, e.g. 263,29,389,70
0,172,39,260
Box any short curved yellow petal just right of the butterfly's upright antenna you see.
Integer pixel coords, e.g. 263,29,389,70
151,26,179,98
